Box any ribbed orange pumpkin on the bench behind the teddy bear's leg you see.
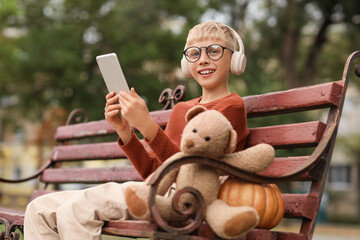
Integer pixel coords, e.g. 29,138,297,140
219,177,284,229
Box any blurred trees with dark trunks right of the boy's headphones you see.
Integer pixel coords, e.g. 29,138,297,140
208,0,360,94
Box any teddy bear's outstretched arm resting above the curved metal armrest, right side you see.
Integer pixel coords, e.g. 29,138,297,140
220,143,275,173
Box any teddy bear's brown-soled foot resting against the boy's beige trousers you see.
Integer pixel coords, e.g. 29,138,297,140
125,183,150,220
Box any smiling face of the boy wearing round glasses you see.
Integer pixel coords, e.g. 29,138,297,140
188,39,232,90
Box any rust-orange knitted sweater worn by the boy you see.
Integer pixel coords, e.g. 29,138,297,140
118,93,249,179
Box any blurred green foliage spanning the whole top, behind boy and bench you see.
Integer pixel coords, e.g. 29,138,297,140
0,0,360,124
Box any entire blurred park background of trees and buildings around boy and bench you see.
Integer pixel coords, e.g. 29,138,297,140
0,0,360,239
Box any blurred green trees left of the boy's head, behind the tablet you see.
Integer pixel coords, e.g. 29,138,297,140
0,0,204,122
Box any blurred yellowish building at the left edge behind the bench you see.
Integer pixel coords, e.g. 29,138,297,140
0,108,67,208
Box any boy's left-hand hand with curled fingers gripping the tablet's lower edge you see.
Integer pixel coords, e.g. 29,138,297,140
104,92,131,138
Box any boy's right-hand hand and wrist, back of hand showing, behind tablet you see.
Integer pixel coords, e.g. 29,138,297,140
119,88,157,141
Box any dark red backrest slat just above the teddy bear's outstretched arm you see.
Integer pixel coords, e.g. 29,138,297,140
247,121,326,148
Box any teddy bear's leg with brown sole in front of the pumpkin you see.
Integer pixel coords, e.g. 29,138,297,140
206,199,259,239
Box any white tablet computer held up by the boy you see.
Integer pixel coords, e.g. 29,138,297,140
96,53,130,93
